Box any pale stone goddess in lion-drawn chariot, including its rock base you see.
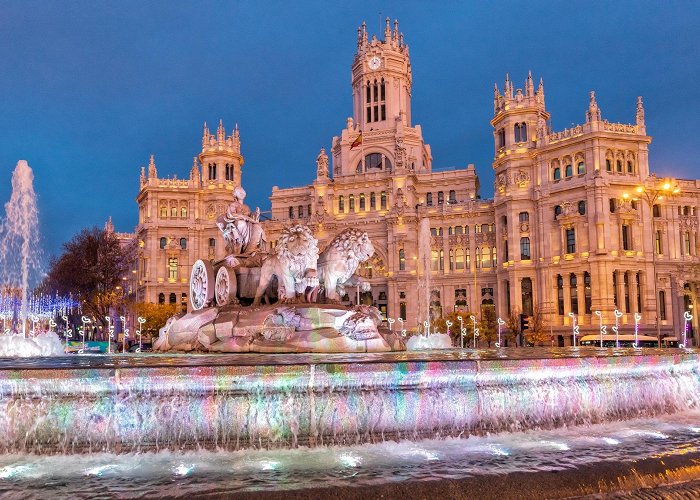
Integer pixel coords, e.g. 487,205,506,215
154,186,404,353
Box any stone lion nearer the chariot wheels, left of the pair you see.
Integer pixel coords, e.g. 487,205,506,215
253,224,318,306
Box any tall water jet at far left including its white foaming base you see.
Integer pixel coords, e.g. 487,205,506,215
0,160,63,356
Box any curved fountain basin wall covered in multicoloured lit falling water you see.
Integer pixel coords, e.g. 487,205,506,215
0,349,700,453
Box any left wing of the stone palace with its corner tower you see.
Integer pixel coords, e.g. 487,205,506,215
135,122,243,310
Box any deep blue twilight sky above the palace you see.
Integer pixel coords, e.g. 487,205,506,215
0,0,700,255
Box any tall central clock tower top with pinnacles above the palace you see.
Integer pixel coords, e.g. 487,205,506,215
352,17,411,131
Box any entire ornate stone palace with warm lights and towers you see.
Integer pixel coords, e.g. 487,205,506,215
137,20,700,345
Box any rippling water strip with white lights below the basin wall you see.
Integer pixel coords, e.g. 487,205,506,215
0,410,700,498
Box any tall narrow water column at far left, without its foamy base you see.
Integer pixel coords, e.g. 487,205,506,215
0,160,41,337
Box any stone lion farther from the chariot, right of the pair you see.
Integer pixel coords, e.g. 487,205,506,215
318,228,374,303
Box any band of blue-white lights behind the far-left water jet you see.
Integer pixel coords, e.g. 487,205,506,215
0,291,80,335
